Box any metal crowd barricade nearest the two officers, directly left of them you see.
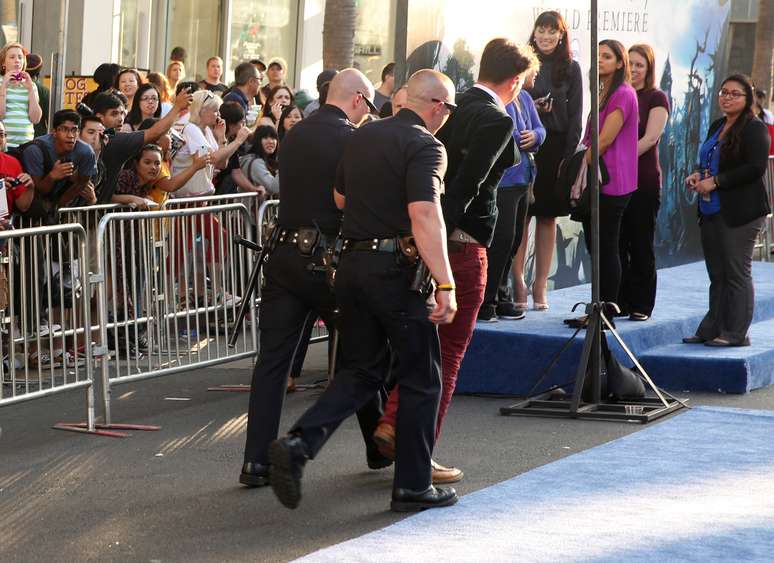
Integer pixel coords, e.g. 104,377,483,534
92,203,257,429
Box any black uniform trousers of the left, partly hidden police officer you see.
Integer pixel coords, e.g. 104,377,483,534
245,243,386,464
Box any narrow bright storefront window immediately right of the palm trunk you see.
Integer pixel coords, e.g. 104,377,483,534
355,0,395,85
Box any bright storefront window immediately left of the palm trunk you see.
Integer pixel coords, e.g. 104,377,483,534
226,0,298,82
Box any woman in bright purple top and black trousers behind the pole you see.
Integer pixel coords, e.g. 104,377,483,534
568,39,638,326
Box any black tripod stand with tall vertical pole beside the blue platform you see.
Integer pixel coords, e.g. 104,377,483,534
500,0,687,423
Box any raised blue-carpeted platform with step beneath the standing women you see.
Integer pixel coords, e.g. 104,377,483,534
457,262,774,395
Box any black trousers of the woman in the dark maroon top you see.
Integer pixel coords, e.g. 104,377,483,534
618,188,661,316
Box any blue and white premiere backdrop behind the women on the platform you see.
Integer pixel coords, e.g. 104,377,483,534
407,0,734,289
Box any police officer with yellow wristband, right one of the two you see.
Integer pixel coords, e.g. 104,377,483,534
269,70,457,511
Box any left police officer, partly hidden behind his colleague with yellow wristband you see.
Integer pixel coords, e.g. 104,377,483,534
239,69,391,487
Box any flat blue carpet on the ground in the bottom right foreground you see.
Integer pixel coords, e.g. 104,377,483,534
301,407,774,563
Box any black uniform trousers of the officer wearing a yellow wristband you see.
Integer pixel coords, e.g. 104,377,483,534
291,251,441,490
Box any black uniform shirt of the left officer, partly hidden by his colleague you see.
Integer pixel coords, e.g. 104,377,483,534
279,104,355,236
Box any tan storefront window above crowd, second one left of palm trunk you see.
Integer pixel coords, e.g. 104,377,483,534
167,0,222,80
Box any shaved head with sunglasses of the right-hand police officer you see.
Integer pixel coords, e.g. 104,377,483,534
406,69,454,133
